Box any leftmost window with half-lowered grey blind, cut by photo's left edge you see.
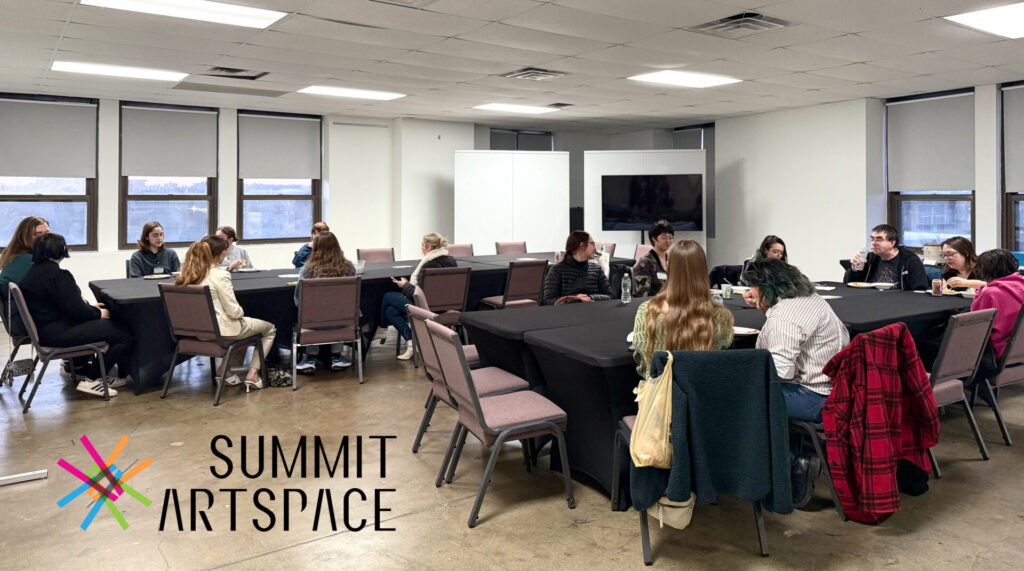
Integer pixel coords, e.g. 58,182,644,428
0,95,97,250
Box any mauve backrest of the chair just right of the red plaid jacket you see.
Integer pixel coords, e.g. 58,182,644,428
931,309,995,385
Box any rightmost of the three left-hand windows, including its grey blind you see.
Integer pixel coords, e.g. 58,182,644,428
236,112,322,243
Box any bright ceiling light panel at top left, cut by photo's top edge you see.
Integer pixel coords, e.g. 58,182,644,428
81,0,288,28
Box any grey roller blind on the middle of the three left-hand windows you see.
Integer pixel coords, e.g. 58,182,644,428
121,104,217,177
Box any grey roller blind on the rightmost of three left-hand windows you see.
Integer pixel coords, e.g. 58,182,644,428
239,112,321,179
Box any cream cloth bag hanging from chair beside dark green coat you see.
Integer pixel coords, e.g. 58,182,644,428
630,352,672,468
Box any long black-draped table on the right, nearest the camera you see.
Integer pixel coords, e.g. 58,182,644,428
461,282,971,508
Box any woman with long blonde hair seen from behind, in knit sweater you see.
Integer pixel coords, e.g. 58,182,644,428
633,239,732,379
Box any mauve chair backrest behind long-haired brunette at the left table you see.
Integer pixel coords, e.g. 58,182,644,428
297,275,362,331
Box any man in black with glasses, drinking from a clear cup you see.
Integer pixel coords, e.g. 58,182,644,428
843,224,931,292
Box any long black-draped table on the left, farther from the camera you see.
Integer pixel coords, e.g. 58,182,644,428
89,252,633,392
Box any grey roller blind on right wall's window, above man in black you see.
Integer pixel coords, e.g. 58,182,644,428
886,93,974,191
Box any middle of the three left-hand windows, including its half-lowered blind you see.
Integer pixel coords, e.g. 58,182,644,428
119,103,217,249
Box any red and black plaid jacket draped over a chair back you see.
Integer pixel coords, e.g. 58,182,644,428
821,323,939,524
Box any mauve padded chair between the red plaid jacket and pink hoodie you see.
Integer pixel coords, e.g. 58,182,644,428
928,309,995,478
